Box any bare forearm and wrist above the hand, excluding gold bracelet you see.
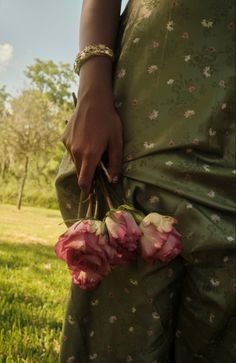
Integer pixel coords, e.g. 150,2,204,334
80,0,121,98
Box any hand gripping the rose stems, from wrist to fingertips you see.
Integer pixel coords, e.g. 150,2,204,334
62,93,122,194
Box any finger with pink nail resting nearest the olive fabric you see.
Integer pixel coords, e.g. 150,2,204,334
107,135,123,183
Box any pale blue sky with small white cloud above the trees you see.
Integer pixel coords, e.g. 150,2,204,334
0,0,128,95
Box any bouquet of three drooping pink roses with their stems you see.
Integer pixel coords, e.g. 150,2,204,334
55,164,181,289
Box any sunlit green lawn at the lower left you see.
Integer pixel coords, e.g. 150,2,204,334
0,205,69,363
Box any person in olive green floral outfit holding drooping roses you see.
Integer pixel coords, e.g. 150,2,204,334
56,0,236,363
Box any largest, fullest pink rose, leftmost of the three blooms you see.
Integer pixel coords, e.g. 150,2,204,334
55,219,116,288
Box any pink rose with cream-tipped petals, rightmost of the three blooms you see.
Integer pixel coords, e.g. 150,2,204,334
139,213,181,264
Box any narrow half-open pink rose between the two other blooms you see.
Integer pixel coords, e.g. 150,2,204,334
105,210,142,261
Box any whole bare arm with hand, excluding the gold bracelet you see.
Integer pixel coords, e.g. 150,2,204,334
62,0,122,193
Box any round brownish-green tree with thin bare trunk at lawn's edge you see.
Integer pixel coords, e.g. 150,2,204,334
5,90,59,209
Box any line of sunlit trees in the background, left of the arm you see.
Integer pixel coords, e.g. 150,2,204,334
0,59,75,209
